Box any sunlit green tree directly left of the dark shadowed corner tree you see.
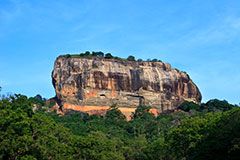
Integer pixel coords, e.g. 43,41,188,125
166,113,221,159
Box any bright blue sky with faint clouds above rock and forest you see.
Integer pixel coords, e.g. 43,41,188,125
0,0,240,104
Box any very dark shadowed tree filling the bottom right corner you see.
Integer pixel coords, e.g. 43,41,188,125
189,108,240,160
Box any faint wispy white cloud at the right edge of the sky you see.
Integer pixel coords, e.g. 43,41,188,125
174,17,240,47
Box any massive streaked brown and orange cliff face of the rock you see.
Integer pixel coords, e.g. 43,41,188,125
52,56,201,116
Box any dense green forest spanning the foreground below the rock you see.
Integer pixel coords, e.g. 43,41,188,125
0,95,240,160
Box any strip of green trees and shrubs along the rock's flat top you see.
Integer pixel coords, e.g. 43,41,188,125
59,51,162,62
